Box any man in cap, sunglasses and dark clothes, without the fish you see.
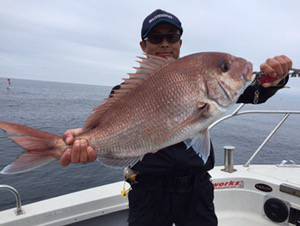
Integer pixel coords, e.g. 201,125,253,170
61,10,292,226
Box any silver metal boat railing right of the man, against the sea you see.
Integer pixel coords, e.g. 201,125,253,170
209,104,300,167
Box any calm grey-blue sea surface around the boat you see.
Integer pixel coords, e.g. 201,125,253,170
0,78,300,210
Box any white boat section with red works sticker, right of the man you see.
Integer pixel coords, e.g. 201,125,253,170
211,165,300,226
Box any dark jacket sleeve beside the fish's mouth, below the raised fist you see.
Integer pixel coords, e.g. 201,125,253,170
237,76,289,104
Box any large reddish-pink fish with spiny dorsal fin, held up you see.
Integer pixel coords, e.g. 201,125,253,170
0,52,252,174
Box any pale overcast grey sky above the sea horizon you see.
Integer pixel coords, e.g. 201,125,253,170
0,0,300,86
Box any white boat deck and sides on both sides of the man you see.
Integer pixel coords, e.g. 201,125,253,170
0,165,300,226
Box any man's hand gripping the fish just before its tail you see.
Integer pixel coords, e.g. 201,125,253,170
60,128,97,166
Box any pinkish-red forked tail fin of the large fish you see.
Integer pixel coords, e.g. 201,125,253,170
0,121,66,174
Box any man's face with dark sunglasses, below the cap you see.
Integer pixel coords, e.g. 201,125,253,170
140,24,182,59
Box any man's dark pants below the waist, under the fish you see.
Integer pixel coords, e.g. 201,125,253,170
128,173,218,226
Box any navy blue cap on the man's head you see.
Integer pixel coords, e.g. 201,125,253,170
141,9,183,39
